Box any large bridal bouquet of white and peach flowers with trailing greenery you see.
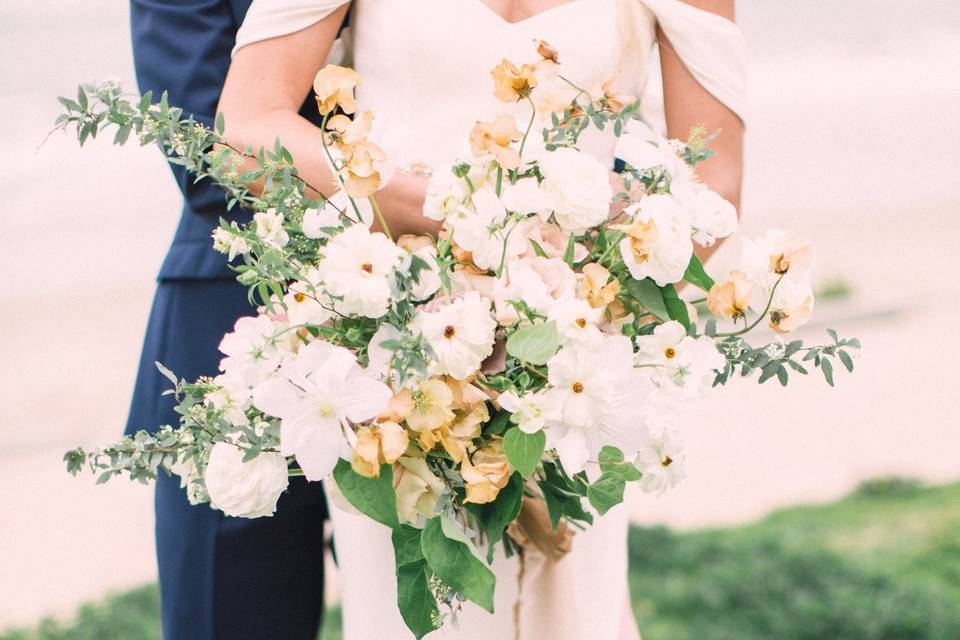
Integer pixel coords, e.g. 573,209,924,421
59,43,859,638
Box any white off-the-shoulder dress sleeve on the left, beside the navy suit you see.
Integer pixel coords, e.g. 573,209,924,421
233,0,350,53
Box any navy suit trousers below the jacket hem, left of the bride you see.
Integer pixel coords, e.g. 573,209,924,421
127,279,326,640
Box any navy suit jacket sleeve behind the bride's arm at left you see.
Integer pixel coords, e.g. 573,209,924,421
130,0,238,217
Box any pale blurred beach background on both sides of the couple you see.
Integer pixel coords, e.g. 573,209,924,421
0,0,960,628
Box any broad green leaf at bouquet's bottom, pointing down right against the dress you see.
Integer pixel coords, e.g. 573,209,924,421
420,516,496,613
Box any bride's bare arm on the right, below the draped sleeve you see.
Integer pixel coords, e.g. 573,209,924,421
657,0,743,258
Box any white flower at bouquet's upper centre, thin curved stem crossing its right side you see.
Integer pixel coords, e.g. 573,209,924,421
452,189,527,270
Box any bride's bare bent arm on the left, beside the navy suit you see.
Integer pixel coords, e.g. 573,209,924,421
217,5,437,235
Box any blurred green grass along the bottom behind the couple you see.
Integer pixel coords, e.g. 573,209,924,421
0,480,960,640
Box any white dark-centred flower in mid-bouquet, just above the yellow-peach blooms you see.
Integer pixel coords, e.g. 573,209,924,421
413,291,497,380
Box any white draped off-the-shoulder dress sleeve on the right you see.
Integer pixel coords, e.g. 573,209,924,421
641,0,747,120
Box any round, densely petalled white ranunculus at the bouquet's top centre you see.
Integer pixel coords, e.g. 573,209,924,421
539,147,613,233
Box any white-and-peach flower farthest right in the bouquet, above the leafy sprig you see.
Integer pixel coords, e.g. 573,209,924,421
742,229,814,284
